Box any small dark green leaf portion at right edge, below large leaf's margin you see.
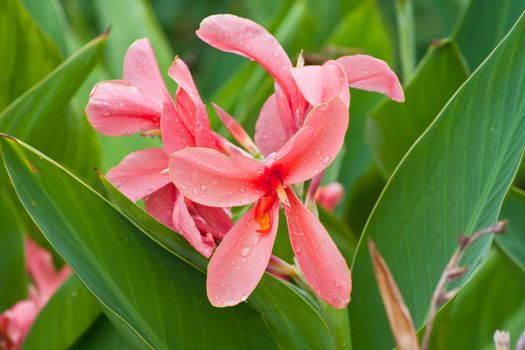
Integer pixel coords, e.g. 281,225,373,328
496,187,525,272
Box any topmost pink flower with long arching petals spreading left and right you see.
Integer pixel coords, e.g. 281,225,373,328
197,15,404,156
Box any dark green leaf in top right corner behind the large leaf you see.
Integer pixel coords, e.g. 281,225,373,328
454,0,525,69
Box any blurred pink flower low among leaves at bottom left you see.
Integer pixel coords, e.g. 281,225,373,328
0,239,71,350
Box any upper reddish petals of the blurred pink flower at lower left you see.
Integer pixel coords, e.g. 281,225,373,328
25,238,71,306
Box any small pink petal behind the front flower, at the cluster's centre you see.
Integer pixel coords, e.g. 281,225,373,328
255,95,288,156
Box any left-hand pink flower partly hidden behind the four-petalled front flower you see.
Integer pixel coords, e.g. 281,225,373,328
86,39,232,257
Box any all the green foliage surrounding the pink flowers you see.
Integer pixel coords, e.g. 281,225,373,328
0,0,525,349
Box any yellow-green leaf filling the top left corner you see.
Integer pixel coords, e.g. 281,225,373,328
0,0,62,110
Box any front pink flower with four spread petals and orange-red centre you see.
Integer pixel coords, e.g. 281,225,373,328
170,97,351,308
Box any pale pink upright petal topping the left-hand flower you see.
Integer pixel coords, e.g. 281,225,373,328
122,39,167,103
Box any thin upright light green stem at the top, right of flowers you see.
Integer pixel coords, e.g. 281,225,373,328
396,0,416,83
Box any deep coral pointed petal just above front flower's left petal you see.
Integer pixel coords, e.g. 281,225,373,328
160,92,195,154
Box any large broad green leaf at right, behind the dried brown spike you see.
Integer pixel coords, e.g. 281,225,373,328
349,12,525,349
